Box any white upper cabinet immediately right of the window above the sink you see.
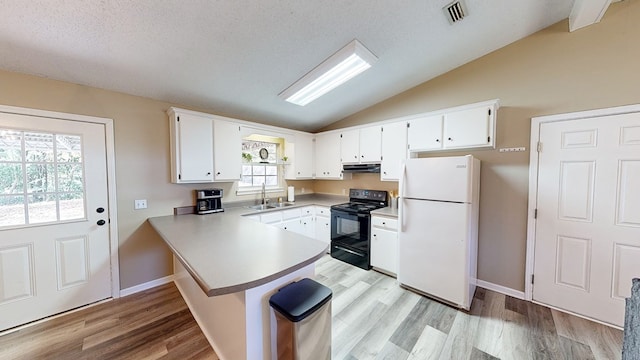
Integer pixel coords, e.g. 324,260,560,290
284,133,314,180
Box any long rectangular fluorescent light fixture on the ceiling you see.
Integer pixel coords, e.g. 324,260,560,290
278,40,378,106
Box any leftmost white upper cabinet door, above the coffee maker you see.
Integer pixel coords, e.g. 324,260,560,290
171,113,213,183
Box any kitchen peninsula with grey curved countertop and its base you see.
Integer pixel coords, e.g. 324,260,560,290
149,208,327,359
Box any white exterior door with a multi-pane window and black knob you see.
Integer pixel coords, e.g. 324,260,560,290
0,113,111,330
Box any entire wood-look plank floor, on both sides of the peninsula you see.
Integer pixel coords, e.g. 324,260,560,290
0,256,622,360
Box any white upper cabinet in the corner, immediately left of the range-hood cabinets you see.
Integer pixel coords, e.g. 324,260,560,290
315,132,342,180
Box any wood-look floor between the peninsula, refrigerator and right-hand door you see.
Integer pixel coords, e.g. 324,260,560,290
316,257,622,360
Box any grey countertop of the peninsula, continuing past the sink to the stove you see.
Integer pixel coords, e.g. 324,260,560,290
149,198,339,296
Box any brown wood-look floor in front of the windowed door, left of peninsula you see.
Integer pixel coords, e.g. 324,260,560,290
0,283,218,360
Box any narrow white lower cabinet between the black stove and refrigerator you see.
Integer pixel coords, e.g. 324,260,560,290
371,216,398,275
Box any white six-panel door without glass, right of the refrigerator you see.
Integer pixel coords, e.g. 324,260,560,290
533,113,640,326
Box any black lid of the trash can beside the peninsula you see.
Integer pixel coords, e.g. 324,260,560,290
269,278,333,322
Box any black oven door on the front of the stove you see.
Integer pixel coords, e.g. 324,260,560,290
331,210,371,270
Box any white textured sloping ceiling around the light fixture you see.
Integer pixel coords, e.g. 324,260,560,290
0,0,584,130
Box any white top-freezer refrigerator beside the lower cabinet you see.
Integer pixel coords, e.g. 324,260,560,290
398,155,480,310
